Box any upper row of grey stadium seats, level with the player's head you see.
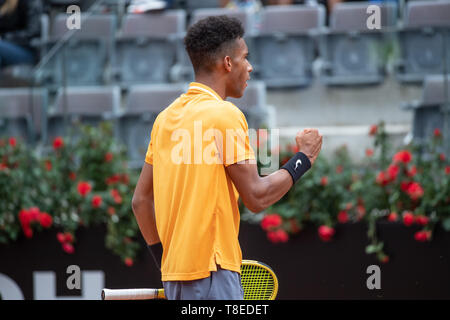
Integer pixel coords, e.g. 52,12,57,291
33,0,450,87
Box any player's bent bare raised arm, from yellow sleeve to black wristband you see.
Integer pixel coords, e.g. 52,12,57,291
226,162,293,213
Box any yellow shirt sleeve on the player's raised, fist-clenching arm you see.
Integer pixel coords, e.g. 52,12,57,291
215,105,255,167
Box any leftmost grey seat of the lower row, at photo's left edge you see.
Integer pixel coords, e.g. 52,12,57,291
0,88,47,144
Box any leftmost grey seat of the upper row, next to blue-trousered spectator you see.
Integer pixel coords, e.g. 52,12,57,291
38,14,116,87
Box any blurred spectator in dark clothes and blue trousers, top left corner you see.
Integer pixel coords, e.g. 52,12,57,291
0,0,42,67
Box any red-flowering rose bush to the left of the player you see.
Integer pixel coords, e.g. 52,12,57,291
0,122,139,265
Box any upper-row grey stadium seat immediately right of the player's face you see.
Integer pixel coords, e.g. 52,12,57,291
250,5,325,88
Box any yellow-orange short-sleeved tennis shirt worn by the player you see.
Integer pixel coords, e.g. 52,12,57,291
145,82,255,281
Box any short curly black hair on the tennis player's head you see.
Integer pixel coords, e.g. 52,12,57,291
184,15,244,72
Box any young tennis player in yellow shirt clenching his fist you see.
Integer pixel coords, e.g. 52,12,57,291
132,16,322,299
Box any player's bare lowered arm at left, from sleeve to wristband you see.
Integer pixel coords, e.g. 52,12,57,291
131,163,161,245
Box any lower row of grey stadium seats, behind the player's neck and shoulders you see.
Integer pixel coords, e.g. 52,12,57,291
0,81,266,165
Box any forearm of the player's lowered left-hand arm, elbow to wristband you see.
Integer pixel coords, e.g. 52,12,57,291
133,199,161,245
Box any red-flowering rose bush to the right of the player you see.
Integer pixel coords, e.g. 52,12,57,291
261,122,450,262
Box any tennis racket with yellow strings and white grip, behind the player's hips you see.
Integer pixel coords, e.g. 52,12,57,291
102,260,278,300
